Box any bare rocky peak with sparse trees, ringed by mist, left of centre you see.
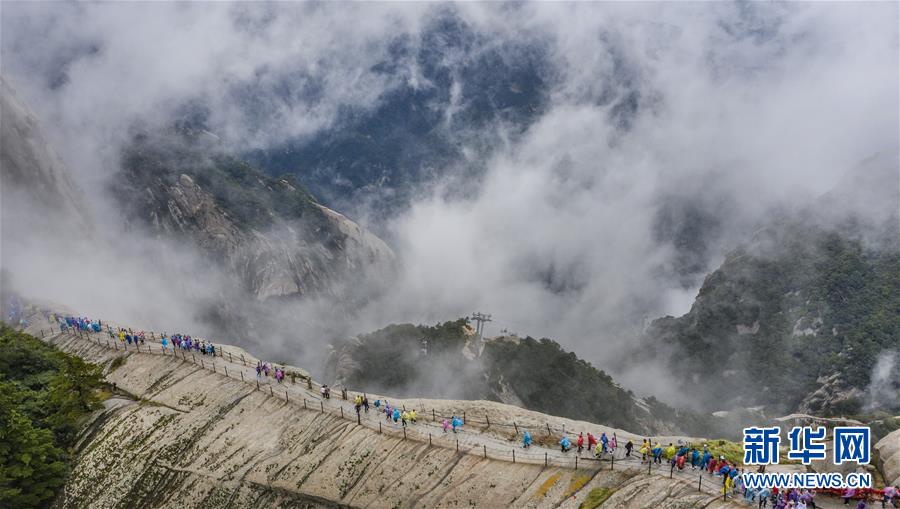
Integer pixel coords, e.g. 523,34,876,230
112,130,394,302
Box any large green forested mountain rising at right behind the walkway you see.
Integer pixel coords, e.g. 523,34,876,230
639,157,900,415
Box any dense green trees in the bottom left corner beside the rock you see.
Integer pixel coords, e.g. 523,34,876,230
0,325,102,508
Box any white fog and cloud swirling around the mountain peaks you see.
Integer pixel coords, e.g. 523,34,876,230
0,2,900,400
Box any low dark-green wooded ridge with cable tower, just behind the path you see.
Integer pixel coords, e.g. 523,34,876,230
327,319,717,433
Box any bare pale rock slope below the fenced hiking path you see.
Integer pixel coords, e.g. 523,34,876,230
29,319,744,509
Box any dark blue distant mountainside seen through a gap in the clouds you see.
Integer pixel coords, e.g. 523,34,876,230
246,7,554,219
